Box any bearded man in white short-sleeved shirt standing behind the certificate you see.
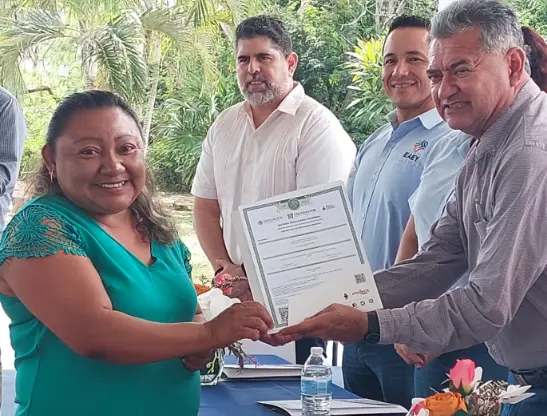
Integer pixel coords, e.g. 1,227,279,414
192,16,356,362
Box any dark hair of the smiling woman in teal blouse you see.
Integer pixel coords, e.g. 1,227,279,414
32,90,177,244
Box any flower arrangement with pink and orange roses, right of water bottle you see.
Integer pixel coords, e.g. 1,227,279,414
408,360,534,416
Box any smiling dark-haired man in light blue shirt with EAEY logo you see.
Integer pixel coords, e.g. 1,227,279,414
343,16,454,407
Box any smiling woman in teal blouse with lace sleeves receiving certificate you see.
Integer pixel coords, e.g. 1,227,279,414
0,91,272,416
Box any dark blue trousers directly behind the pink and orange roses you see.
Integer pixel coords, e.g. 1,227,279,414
414,344,510,398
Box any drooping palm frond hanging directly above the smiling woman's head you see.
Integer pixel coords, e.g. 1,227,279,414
81,14,148,103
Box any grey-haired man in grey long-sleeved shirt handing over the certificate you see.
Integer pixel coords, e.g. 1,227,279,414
279,0,547,416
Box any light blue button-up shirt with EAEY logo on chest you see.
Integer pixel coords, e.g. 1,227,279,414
347,109,452,271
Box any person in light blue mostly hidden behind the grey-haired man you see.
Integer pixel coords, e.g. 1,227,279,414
395,27,547,397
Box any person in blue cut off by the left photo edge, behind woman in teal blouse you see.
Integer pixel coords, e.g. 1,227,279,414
0,84,27,404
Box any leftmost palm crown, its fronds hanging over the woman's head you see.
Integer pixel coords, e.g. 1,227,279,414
0,1,147,102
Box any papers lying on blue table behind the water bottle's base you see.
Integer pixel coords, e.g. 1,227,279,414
258,399,407,416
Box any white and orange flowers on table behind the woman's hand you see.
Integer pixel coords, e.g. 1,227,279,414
194,275,256,372
